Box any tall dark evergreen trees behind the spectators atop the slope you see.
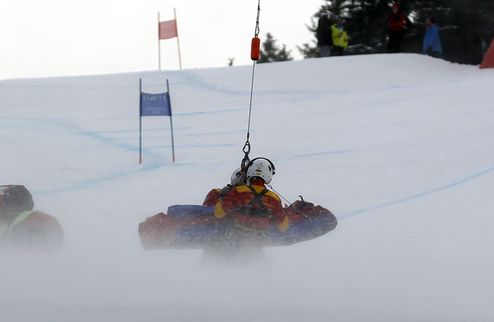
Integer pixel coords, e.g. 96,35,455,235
299,0,494,64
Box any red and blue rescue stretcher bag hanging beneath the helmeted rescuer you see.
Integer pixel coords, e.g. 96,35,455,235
139,201,337,249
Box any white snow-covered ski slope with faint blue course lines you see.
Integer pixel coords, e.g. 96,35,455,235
0,54,494,322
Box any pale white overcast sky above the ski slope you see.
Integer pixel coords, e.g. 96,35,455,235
0,0,325,79
